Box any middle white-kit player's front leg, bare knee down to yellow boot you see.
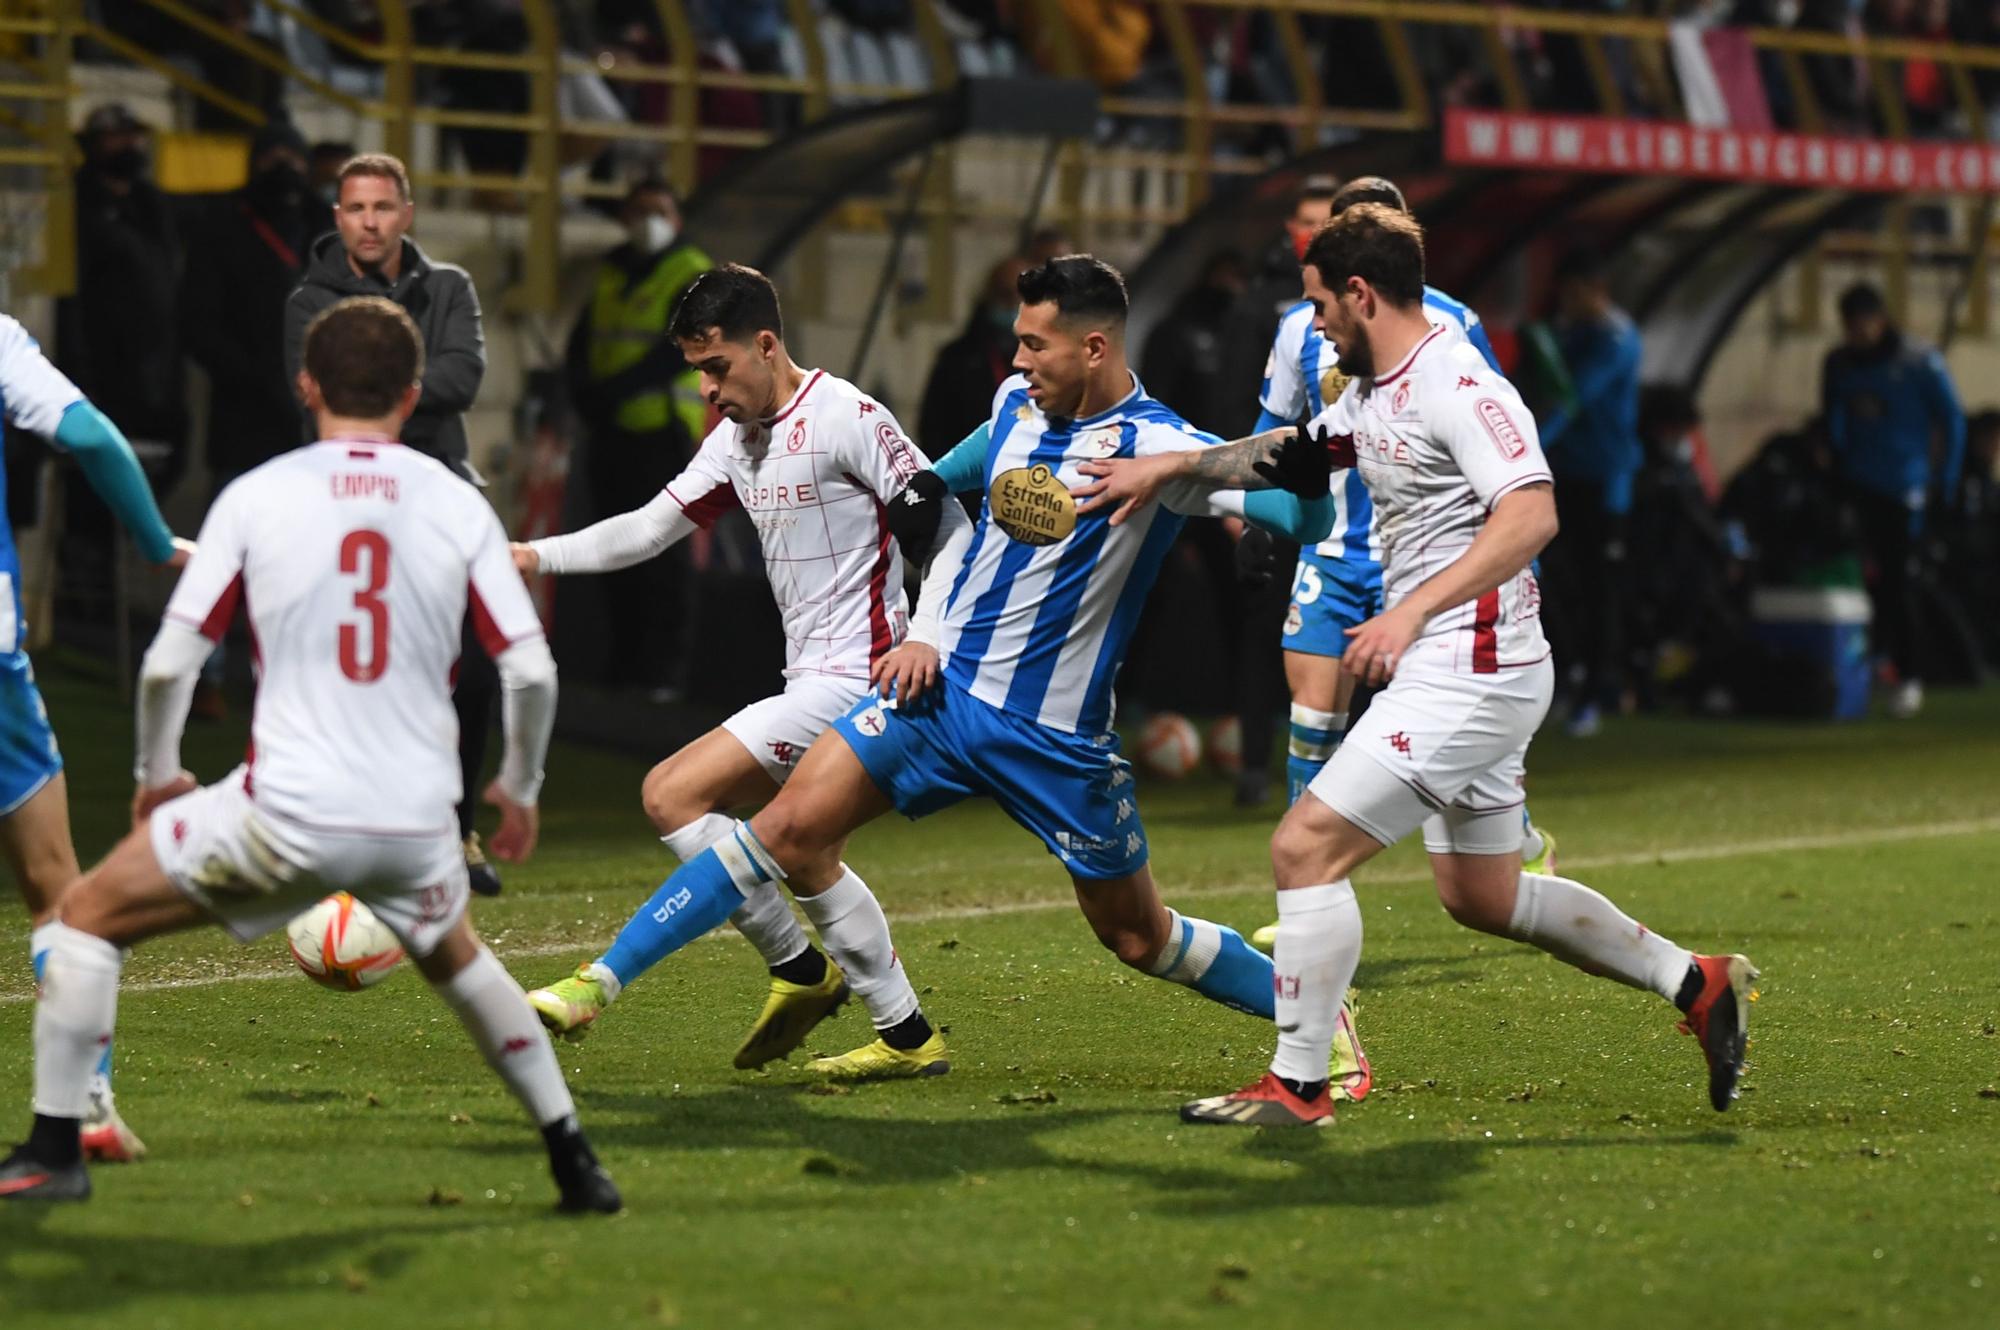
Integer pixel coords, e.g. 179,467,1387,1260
640,728,848,1070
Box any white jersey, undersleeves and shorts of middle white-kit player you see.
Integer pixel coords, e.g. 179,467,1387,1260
530,370,968,784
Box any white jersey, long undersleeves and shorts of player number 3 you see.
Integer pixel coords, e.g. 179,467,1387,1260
138,440,554,956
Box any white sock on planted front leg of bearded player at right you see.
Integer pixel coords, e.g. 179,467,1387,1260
1270,878,1362,1080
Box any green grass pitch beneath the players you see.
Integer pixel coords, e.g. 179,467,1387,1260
0,668,2000,1330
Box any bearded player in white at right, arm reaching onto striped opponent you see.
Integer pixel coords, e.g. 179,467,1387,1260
1080,213,1756,1126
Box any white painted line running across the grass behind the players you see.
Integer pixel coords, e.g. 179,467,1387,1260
0,818,2000,1006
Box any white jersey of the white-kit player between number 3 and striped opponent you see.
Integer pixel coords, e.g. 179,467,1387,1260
666,370,924,678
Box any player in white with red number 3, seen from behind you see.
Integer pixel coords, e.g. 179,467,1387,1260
0,298,620,1212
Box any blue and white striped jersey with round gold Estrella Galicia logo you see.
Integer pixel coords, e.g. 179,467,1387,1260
938,374,1242,736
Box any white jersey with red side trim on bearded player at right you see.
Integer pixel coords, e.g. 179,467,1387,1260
1314,328,1552,674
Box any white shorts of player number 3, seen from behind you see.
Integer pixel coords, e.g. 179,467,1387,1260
148,768,468,956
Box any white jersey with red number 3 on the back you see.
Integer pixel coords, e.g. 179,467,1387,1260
166,440,542,834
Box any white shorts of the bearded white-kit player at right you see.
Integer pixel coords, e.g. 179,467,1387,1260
1308,650,1556,854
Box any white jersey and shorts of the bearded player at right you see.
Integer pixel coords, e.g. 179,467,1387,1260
1310,328,1554,854
